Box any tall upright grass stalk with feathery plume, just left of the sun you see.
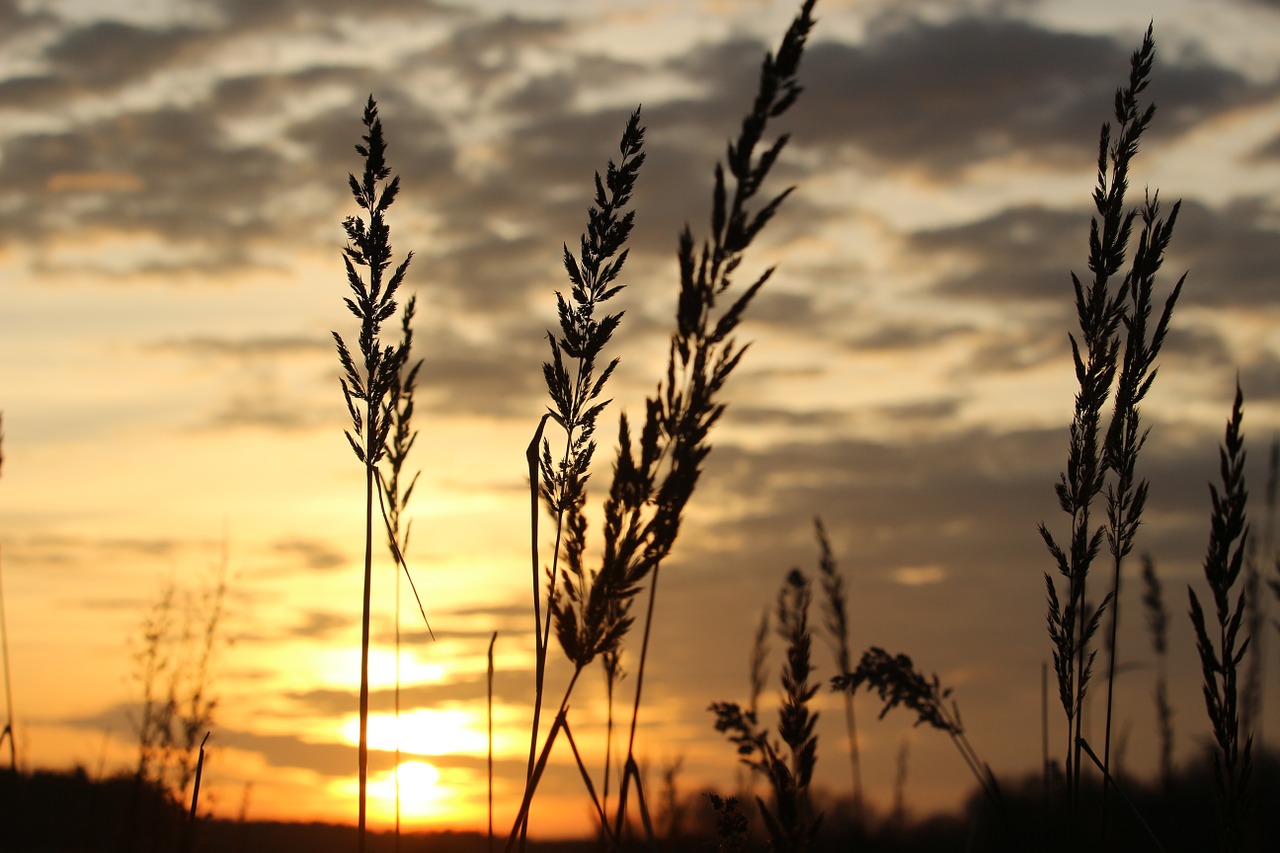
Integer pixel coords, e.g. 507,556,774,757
333,96,413,853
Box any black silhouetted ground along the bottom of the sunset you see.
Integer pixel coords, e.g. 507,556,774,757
0,754,1280,853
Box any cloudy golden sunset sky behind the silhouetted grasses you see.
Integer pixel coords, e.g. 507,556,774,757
0,0,1280,834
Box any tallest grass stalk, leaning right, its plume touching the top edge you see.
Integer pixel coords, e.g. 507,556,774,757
600,0,814,834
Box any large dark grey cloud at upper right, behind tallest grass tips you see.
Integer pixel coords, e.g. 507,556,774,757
773,18,1260,177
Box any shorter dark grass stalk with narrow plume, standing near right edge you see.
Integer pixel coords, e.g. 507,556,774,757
1187,383,1253,853
